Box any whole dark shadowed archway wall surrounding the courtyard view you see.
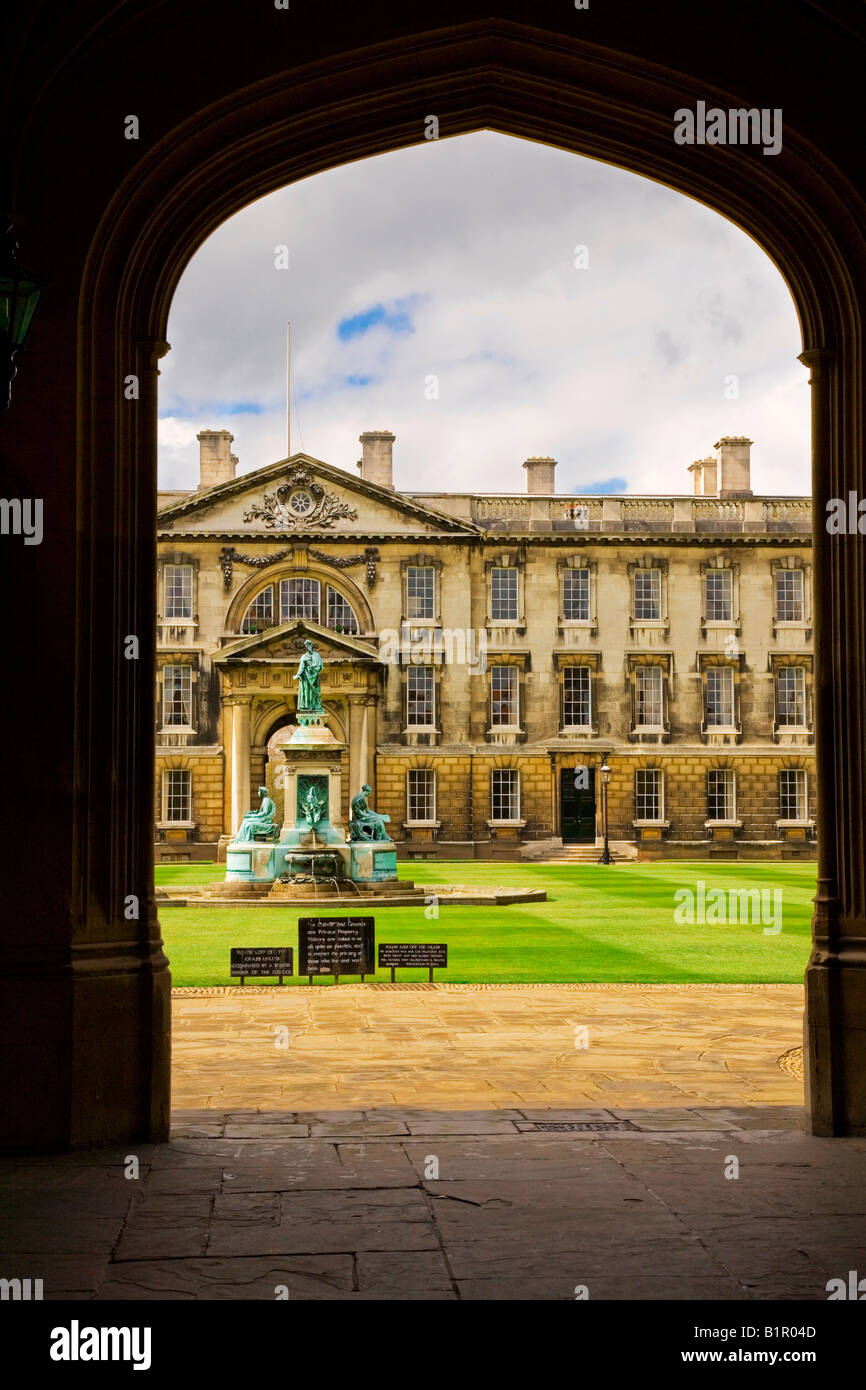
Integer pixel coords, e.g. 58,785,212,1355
0,0,866,1147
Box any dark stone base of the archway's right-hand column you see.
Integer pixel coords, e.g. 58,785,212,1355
803,956,866,1137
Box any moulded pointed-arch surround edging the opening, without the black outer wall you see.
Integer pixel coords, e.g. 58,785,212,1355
8,21,866,1143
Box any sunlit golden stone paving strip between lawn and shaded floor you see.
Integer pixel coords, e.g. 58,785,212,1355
174,984,803,1111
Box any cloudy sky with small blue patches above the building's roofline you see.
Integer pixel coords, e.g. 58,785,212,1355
160,131,810,493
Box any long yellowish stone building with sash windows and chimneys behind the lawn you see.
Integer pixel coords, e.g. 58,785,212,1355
156,430,815,859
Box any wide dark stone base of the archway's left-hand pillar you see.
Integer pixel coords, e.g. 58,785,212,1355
0,945,171,1152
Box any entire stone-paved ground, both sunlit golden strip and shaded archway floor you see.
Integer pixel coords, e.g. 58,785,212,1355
0,986,866,1301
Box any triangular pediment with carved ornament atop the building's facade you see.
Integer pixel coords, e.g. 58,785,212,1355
157,453,478,539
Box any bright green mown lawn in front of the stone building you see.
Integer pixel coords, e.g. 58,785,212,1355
156,860,816,986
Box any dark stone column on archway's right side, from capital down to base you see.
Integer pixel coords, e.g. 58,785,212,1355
799,349,866,1136
